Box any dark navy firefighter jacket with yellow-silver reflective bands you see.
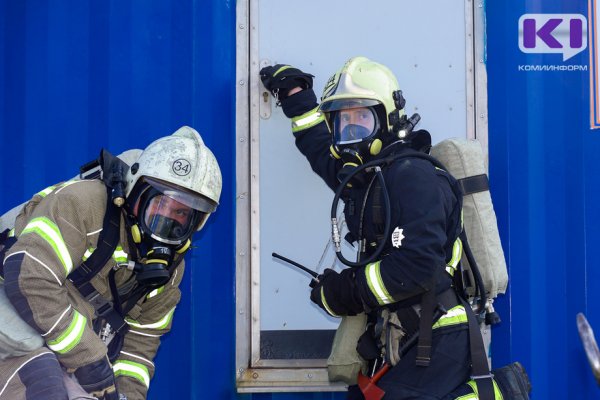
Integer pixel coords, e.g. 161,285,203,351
283,96,467,328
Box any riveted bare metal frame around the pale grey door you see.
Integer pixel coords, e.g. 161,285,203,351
235,0,488,392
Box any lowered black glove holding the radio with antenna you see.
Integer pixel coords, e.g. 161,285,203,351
310,268,364,317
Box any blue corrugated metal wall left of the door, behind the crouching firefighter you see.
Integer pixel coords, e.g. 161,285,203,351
0,0,236,399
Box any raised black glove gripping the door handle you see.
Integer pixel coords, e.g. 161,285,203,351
260,64,314,103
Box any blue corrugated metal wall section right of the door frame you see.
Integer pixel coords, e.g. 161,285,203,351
486,0,600,400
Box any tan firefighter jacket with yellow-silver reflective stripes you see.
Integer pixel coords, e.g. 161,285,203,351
4,180,184,400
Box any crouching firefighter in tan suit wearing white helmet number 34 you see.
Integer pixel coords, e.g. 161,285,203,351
0,127,221,400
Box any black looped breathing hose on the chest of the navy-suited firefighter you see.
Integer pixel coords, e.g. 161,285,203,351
331,157,394,267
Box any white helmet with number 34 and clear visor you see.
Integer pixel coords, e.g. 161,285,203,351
126,126,222,244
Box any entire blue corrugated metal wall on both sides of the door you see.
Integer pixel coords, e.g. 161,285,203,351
0,0,600,400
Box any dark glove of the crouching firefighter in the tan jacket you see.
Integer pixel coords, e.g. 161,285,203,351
75,357,119,400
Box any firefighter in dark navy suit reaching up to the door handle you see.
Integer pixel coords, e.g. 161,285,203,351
260,57,529,399
